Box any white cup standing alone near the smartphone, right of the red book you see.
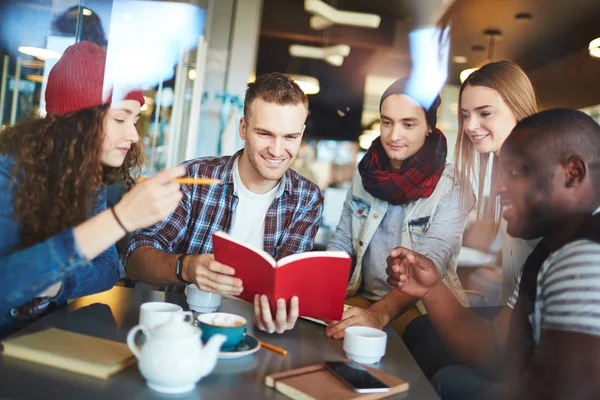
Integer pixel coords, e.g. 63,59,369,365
344,326,387,364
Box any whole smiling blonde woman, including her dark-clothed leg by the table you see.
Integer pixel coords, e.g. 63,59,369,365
403,61,538,378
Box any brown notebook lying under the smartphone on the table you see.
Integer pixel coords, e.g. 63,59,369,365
265,364,408,400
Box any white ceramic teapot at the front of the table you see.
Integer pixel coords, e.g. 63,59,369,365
127,314,226,394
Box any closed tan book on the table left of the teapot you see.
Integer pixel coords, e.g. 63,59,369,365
2,328,136,379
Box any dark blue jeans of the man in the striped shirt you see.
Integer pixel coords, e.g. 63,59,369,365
431,365,509,400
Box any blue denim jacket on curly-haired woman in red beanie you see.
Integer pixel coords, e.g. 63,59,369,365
0,155,123,328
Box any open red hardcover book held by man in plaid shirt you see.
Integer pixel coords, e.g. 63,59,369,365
213,232,352,321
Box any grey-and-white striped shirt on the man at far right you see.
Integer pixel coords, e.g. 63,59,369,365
507,240,600,343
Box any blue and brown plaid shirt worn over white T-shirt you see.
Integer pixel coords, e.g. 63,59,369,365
125,150,323,290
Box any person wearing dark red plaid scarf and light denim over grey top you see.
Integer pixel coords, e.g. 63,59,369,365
326,78,472,339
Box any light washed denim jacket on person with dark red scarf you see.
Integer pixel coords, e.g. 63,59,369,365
327,165,468,313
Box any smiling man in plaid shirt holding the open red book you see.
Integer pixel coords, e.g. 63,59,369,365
125,73,323,333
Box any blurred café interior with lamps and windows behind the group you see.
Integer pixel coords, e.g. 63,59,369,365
0,0,600,304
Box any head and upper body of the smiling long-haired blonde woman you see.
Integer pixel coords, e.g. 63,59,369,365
454,61,537,305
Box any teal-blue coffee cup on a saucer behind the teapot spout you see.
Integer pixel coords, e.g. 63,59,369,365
197,313,248,351
